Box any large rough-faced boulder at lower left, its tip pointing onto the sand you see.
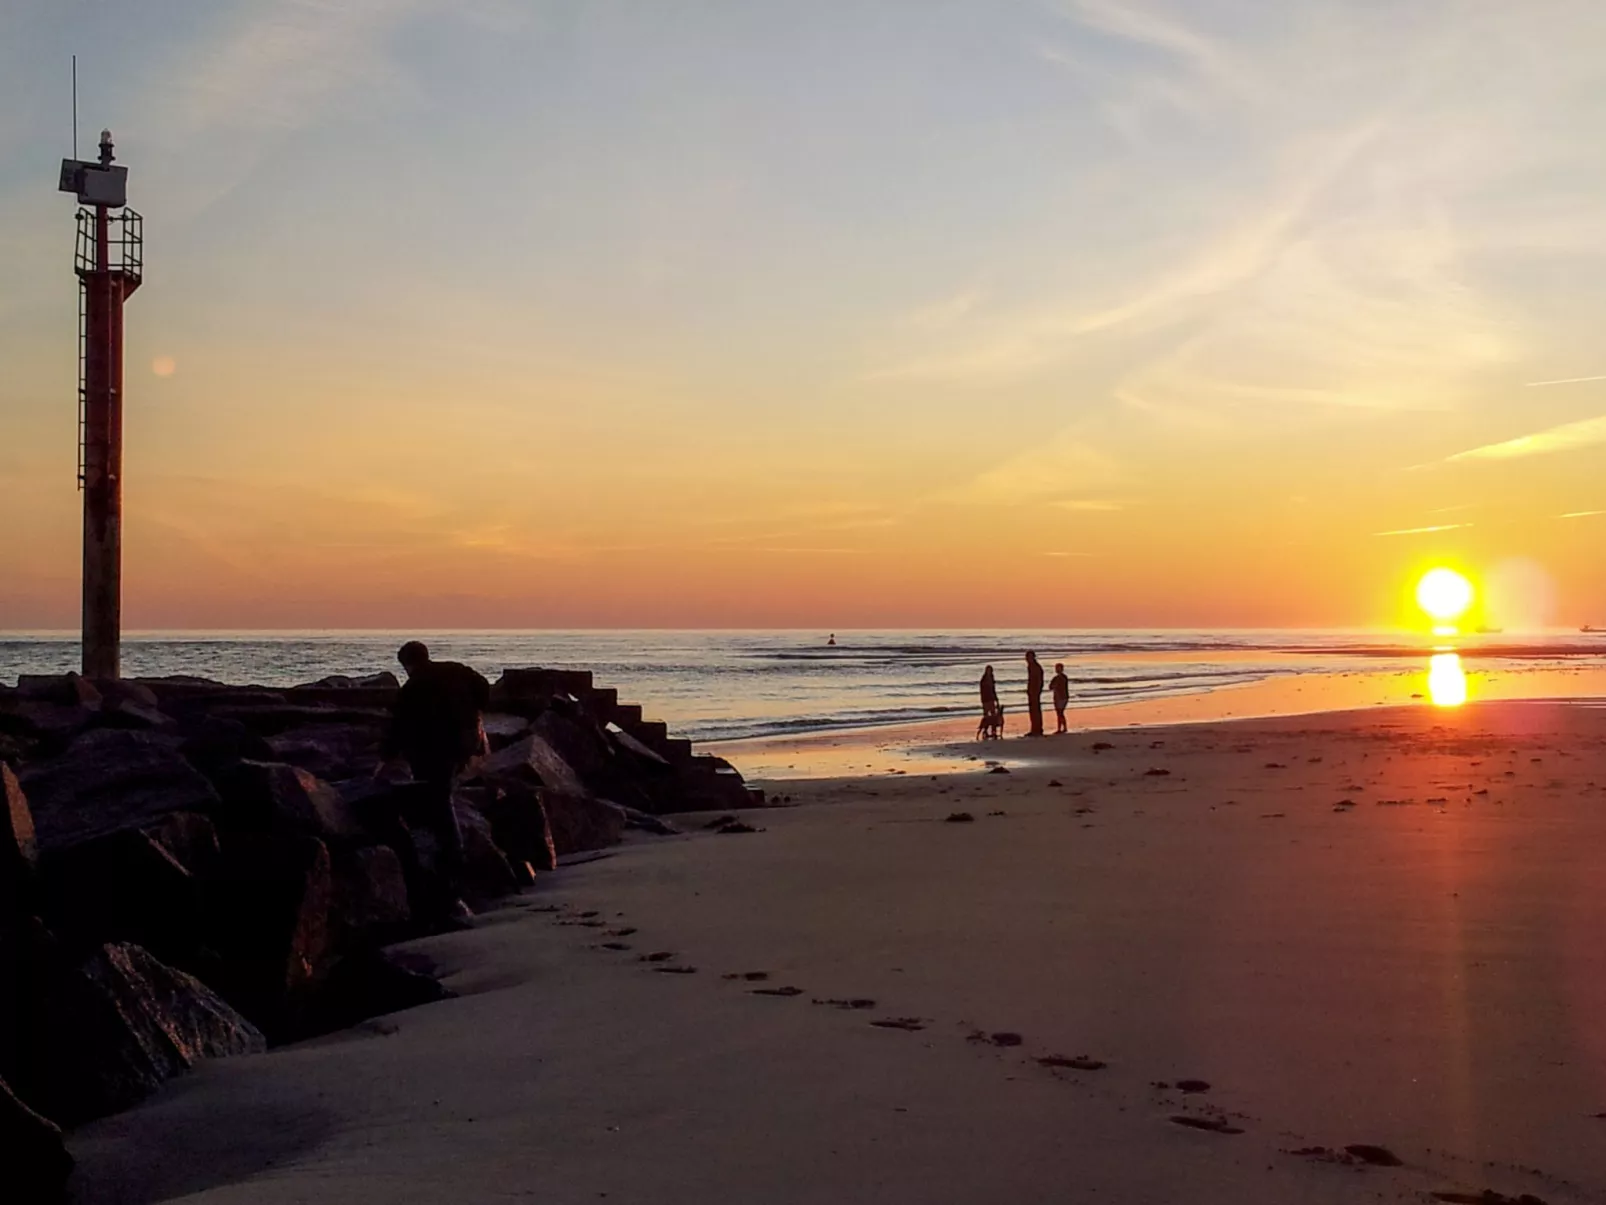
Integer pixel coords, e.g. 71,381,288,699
40,943,267,1125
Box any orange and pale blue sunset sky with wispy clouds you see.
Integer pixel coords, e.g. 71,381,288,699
0,0,1606,630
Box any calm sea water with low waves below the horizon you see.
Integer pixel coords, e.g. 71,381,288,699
0,630,1606,741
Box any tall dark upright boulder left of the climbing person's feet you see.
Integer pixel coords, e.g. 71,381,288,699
202,834,336,1036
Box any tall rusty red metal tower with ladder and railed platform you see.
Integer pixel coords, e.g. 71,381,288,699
61,130,145,678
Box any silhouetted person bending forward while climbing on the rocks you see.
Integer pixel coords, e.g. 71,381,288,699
374,639,491,917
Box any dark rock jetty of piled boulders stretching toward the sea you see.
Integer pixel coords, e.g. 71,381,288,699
0,668,763,1202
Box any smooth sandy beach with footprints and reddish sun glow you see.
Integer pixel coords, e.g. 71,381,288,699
72,702,1606,1205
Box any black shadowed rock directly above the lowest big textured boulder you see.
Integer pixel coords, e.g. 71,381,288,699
39,829,201,964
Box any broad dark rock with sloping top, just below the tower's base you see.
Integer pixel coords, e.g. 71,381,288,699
21,729,218,852
